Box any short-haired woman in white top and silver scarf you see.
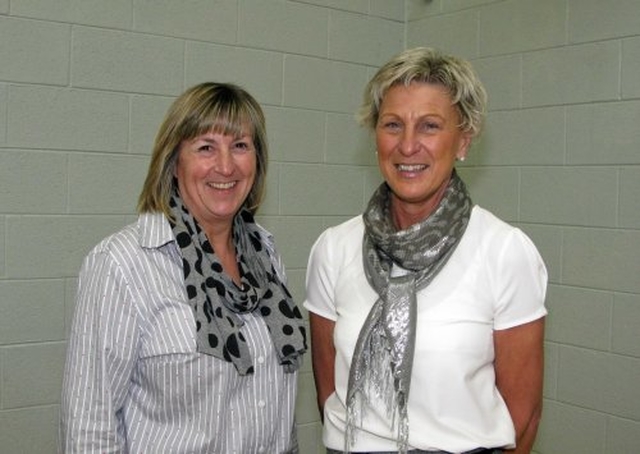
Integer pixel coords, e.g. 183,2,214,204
305,48,547,453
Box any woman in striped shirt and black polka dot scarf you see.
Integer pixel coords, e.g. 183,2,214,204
60,83,306,454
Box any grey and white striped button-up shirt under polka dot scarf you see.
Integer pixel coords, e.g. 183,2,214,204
60,214,298,454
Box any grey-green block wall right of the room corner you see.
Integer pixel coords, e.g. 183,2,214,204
407,0,640,454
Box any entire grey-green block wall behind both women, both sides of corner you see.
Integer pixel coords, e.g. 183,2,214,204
0,0,640,454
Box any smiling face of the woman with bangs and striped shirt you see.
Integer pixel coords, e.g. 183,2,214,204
175,127,257,234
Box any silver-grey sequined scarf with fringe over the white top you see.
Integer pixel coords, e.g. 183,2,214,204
345,171,472,453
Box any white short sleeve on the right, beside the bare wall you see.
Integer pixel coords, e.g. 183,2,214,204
492,228,548,330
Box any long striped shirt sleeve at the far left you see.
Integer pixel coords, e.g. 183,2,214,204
60,252,140,453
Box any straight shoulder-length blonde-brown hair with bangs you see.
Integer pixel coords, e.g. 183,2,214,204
138,82,268,218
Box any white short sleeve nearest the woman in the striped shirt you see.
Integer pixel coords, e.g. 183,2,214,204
304,229,339,321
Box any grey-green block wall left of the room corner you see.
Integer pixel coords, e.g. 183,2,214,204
0,0,405,454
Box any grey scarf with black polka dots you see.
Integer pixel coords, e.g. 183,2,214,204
170,189,307,375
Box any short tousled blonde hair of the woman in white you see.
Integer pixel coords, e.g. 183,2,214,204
359,47,487,137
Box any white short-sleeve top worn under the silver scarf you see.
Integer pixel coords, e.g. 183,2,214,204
304,206,547,452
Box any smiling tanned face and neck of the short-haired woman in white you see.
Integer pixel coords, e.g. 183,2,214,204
375,82,471,229
